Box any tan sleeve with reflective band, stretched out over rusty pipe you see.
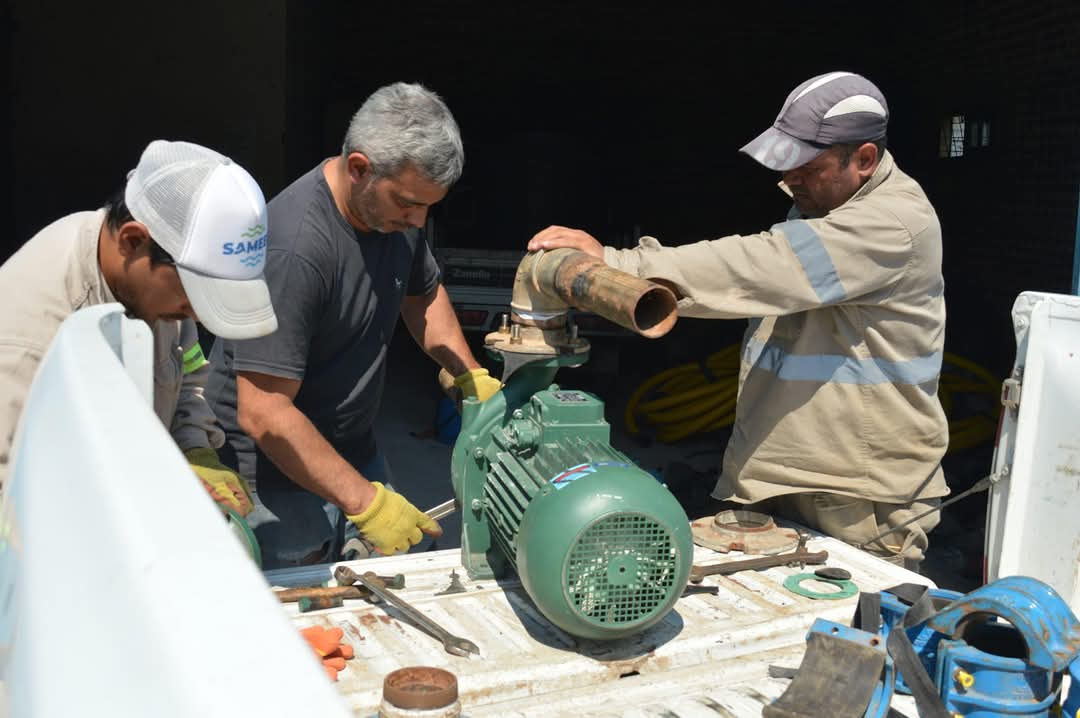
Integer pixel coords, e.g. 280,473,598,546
604,198,912,319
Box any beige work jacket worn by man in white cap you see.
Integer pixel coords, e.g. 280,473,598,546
0,209,225,484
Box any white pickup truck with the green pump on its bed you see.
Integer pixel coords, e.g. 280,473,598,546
0,293,1080,718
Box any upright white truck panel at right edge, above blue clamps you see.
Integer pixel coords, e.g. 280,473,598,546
986,292,1080,612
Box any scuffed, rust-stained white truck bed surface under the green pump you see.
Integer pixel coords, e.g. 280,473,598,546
274,537,929,718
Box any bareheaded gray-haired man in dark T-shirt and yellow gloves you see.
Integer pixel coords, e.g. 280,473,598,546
207,83,500,568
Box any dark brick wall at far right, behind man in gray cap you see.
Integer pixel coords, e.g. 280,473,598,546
893,0,1080,372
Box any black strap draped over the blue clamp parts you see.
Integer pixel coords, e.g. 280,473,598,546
851,583,950,718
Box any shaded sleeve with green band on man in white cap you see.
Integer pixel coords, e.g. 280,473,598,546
168,320,225,451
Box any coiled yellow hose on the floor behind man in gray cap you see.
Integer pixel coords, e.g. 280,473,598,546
624,344,1001,451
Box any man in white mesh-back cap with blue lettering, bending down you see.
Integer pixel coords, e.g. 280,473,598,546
0,140,278,515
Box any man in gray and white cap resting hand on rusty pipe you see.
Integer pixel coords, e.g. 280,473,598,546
528,72,948,569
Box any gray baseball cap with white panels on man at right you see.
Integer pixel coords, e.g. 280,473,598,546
739,72,889,172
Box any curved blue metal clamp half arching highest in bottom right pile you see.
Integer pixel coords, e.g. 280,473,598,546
928,575,1080,673
